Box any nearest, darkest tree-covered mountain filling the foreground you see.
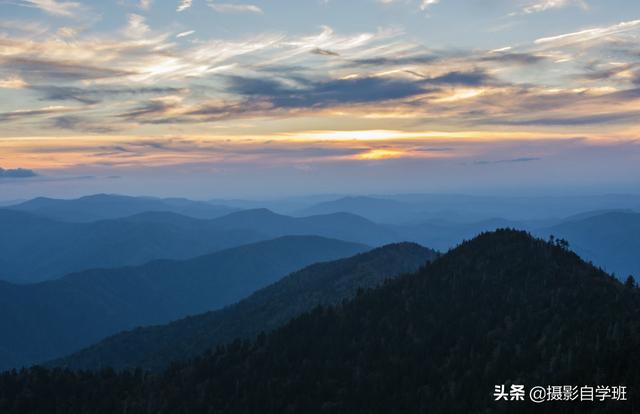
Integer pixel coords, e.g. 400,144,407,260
0,230,640,414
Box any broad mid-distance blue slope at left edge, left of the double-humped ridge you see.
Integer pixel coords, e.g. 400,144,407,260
0,209,268,283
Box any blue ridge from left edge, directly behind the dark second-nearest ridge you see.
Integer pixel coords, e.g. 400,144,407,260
0,236,368,368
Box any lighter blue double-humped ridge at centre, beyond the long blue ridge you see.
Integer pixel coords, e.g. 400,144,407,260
212,209,399,245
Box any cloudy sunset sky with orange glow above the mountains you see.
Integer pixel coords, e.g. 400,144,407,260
0,0,640,200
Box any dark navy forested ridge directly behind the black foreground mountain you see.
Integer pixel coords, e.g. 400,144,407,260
47,243,437,370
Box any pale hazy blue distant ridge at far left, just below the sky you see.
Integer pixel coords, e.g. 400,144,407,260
10,194,237,222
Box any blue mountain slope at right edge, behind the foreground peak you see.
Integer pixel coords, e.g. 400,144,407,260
537,212,640,279
